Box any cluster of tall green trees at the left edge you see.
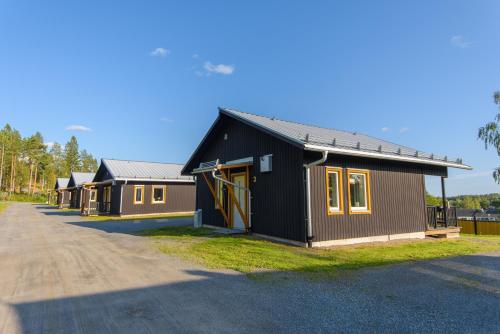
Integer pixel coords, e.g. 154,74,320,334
0,124,98,195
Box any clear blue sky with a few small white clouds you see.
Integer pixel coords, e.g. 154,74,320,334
0,0,500,195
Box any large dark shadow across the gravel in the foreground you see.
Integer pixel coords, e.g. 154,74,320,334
9,254,500,333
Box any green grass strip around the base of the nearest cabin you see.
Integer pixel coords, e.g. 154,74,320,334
141,227,500,274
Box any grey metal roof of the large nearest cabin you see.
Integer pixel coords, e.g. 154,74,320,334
219,108,470,169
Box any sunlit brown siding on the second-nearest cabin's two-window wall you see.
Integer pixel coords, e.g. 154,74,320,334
118,183,196,215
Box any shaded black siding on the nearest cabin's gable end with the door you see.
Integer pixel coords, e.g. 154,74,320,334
193,115,305,242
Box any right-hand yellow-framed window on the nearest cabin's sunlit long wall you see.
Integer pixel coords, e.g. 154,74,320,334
347,169,371,214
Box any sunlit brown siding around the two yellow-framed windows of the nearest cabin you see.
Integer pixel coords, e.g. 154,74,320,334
311,156,438,241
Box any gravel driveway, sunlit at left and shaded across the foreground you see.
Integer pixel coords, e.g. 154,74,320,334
0,204,500,334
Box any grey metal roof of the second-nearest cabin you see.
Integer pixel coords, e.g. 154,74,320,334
102,159,194,182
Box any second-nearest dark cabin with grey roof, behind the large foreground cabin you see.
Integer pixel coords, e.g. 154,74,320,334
81,159,196,216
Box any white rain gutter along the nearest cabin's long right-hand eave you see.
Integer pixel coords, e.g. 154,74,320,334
304,144,472,170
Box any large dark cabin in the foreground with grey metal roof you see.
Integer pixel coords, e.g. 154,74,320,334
182,108,470,246
